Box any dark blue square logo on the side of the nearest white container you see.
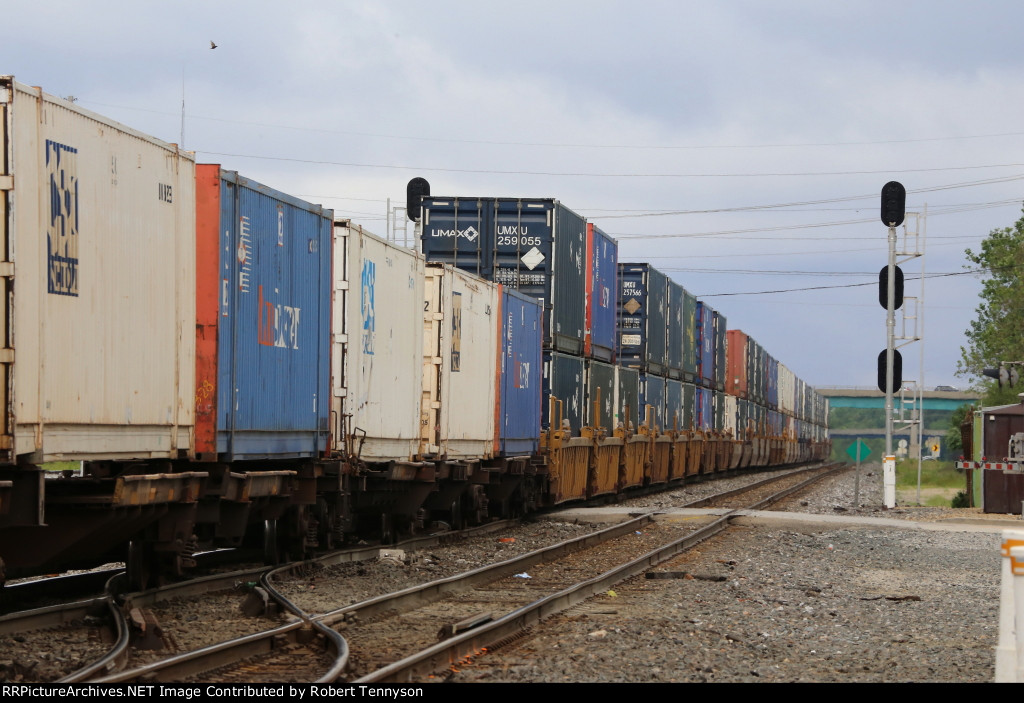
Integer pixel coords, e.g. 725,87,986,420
46,139,78,297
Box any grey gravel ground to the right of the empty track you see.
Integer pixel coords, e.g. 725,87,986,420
446,468,1007,683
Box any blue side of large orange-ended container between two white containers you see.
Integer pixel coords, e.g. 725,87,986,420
205,171,334,460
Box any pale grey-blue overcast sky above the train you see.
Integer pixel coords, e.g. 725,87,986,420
8,0,1024,388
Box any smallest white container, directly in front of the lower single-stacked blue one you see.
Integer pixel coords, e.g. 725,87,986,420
420,264,501,458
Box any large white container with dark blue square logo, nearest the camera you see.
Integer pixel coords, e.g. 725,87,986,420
0,76,196,462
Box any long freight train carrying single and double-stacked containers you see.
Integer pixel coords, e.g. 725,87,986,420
0,77,828,586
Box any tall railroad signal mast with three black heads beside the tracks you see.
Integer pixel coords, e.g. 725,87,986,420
878,181,925,508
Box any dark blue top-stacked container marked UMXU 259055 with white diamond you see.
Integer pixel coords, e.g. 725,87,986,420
421,196,587,354
